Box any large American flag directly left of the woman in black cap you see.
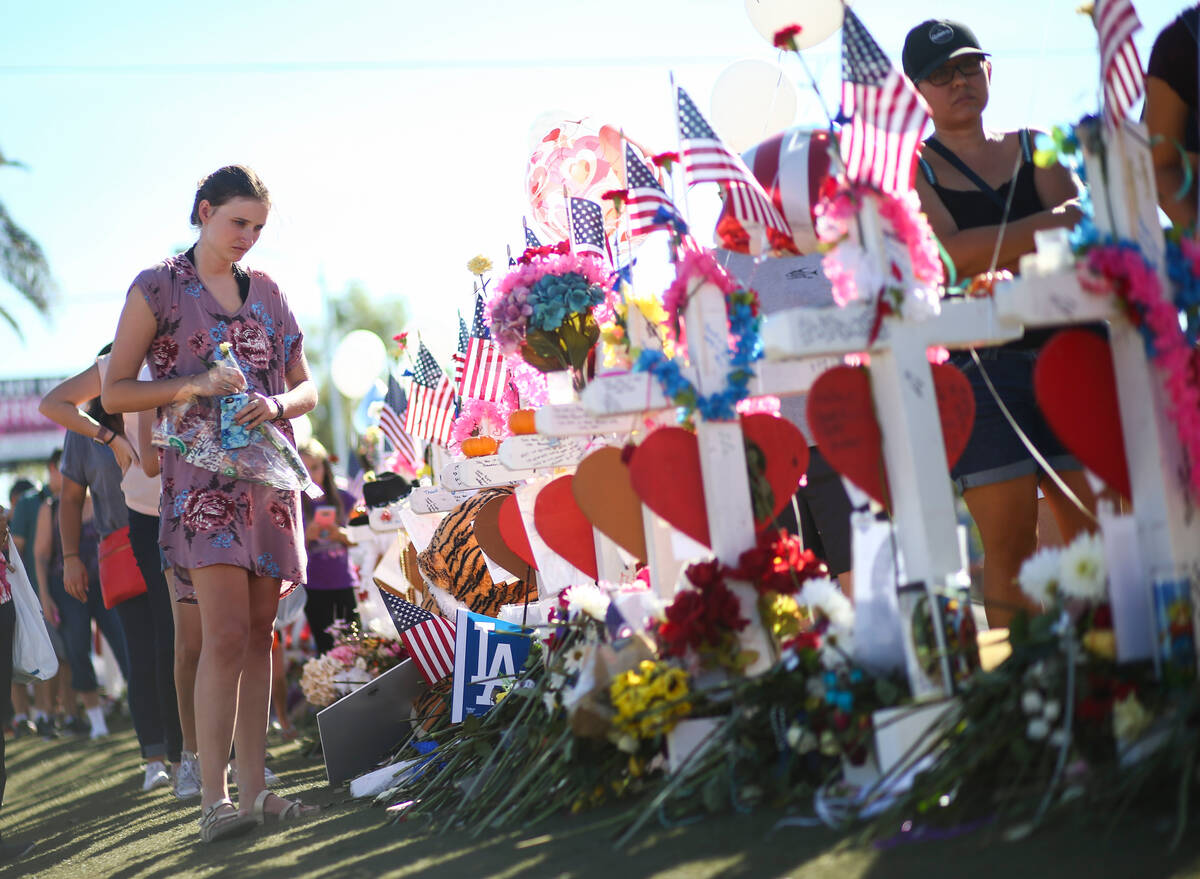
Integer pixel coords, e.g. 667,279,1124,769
841,7,929,193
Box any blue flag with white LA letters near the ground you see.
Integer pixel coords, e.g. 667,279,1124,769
450,608,533,723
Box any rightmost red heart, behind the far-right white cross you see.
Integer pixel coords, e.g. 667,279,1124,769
1033,330,1132,498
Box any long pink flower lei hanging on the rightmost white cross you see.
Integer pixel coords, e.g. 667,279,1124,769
1079,245,1200,500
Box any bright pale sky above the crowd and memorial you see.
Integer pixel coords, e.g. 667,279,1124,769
0,0,1183,377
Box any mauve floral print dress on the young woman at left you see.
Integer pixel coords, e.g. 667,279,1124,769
131,253,307,600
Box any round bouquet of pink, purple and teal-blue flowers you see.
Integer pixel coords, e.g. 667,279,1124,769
487,243,611,388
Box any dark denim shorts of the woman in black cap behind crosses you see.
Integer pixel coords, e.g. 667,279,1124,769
950,348,1082,491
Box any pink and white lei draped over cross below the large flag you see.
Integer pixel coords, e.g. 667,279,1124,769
814,185,946,306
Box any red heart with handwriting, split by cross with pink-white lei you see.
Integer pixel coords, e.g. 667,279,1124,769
808,363,974,507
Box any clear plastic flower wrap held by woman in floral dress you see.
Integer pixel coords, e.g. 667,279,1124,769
152,397,322,497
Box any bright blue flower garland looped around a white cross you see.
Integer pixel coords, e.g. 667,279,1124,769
634,280,762,421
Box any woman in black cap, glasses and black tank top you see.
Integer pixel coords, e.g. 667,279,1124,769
904,19,1094,626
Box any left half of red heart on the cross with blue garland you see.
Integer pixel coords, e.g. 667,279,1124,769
629,427,710,546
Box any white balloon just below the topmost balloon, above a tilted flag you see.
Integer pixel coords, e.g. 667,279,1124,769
712,58,797,153
